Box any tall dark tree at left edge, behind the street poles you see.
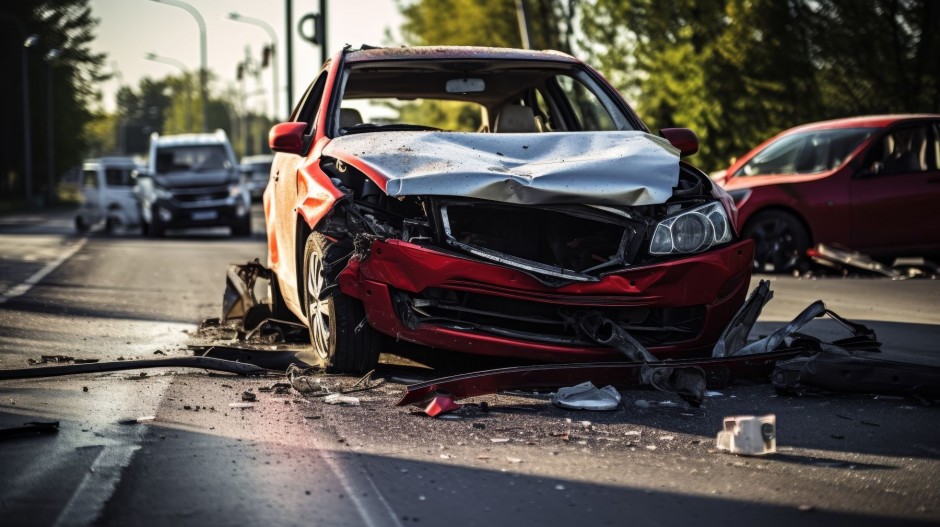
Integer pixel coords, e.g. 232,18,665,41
0,0,107,205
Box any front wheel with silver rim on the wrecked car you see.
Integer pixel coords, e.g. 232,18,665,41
303,232,382,373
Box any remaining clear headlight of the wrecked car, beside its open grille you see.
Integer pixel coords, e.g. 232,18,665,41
650,201,731,254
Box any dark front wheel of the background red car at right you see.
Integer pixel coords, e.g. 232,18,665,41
743,210,810,273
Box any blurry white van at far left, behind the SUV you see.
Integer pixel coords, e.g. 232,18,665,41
75,157,140,232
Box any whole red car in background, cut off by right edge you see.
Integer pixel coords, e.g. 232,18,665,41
718,114,940,272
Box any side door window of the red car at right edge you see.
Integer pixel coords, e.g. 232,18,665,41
865,124,938,175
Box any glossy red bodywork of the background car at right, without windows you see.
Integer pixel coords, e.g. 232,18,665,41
717,114,940,254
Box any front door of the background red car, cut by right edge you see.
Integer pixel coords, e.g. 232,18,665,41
850,121,940,252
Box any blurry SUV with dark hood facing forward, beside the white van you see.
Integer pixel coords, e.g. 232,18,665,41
136,130,251,237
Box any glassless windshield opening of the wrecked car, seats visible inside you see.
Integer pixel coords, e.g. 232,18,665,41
334,60,635,136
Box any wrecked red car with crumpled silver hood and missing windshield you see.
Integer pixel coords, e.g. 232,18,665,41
264,47,753,372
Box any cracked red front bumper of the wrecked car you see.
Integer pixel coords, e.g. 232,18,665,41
340,240,753,362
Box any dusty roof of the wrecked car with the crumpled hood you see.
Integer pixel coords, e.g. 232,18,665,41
345,46,581,64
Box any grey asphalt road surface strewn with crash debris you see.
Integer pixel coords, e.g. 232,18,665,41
0,207,940,527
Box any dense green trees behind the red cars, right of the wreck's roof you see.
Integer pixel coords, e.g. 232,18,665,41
582,0,940,168
